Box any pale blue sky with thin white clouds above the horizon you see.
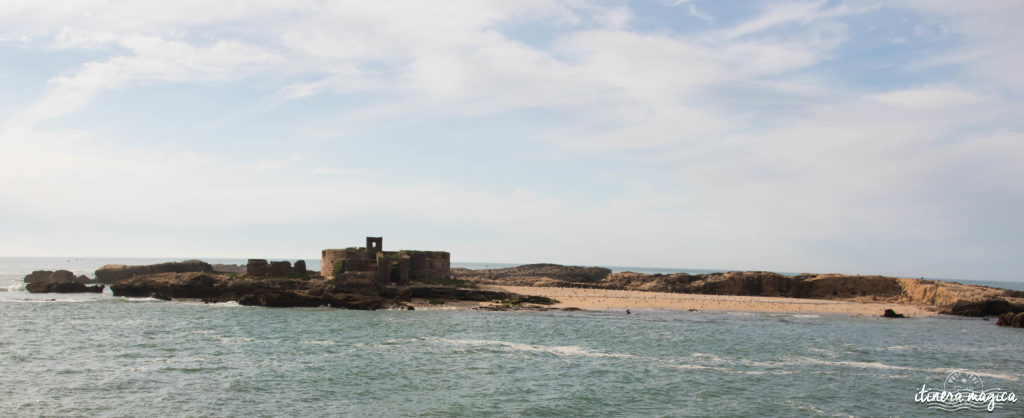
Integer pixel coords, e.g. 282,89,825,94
0,0,1024,282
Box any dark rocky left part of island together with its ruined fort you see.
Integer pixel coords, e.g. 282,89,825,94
25,237,557,309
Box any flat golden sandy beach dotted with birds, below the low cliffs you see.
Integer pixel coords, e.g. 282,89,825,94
487,286,937,317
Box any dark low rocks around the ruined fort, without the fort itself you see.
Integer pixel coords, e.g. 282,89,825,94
25,260,557,309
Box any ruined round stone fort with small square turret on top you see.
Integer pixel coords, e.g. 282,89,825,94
321,237,451,284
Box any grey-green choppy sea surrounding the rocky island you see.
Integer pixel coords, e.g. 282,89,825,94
0,258,1024,417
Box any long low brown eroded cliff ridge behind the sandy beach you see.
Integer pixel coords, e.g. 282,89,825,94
453,264,1024,315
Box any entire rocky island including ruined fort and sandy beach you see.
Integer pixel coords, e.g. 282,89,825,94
25,237,1024,327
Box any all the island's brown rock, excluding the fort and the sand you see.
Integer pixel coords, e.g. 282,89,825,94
25,260,1024,328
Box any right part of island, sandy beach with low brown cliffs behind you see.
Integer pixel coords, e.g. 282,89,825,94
452,264,1024,327
